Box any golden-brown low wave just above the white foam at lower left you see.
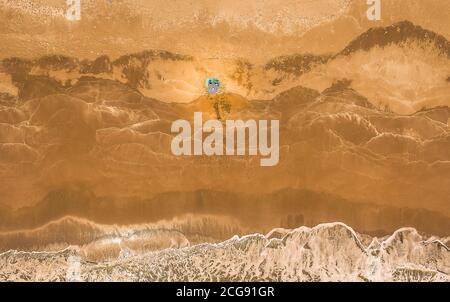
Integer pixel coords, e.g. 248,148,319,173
0,215,247,261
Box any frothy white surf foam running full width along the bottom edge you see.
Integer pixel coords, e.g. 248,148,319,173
0,223,450,281
